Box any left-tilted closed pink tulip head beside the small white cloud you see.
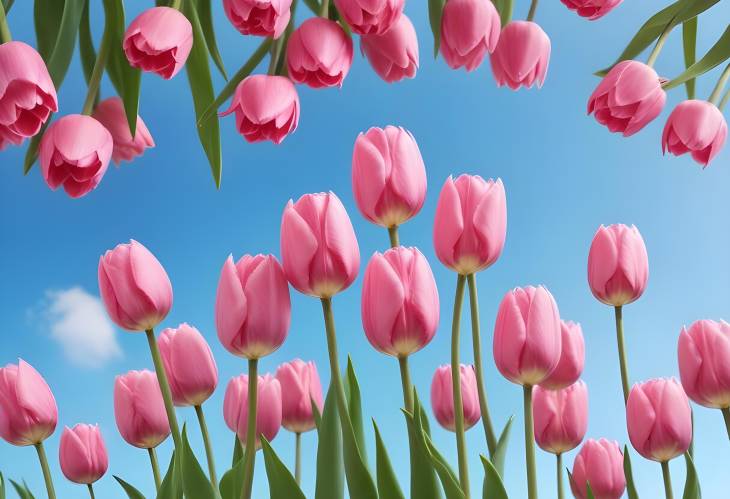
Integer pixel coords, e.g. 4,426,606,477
99,239,172,331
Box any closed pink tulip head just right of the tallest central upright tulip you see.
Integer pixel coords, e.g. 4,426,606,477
433,175,507,275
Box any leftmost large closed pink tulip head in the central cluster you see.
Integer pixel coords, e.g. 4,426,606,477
215,255,291,359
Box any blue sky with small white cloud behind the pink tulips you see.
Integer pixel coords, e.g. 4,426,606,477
0,0,730,498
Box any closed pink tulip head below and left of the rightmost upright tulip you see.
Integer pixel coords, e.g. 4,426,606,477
626,379,692,462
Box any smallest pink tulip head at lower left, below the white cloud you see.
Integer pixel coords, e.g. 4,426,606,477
58,424,109,484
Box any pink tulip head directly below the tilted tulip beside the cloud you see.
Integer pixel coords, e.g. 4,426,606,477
114,369,170,449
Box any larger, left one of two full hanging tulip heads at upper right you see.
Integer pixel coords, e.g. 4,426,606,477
588,61,667,137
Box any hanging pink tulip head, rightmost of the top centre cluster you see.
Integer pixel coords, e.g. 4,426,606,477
490,21,550,90
